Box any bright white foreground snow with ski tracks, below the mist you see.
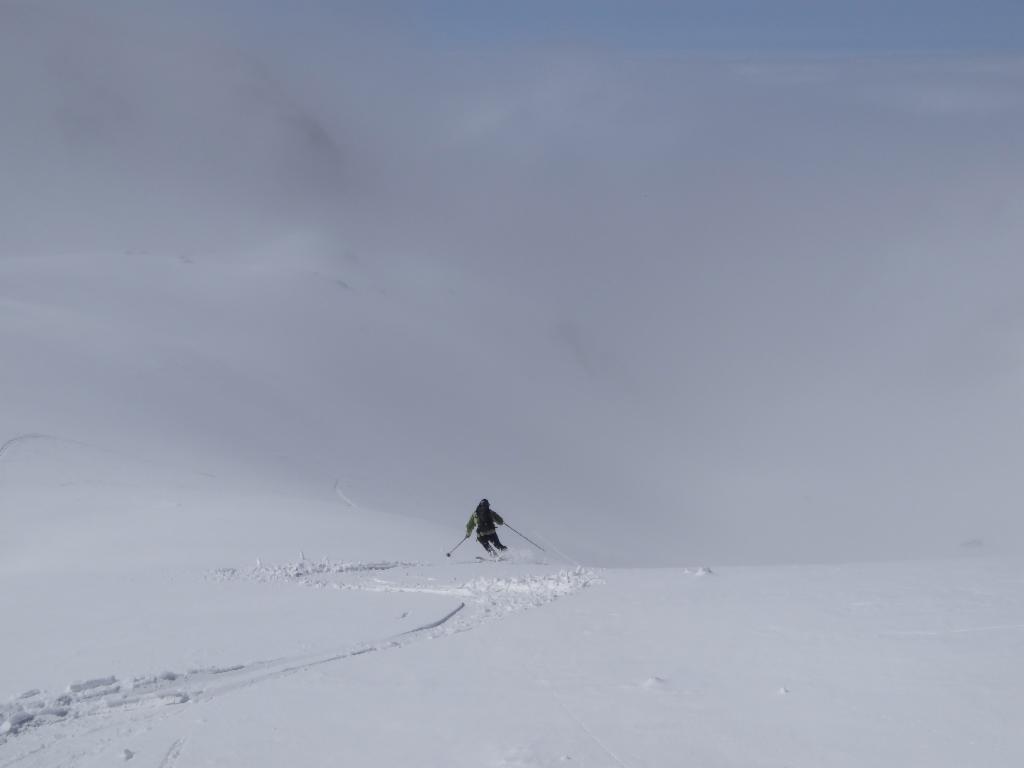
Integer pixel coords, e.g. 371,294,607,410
0,438,1024,768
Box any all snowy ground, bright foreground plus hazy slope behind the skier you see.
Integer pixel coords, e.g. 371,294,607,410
0,237,1024,768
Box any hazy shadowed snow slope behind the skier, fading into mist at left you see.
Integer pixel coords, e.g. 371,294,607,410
0,249,651,559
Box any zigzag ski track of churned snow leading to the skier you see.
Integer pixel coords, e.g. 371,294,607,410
0,560,598,768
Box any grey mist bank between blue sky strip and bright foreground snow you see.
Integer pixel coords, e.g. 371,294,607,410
0,3,1024,563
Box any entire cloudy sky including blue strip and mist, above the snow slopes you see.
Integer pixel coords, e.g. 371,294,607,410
0,0,1024,562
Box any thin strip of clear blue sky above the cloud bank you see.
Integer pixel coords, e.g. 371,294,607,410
224,0,1024,53
